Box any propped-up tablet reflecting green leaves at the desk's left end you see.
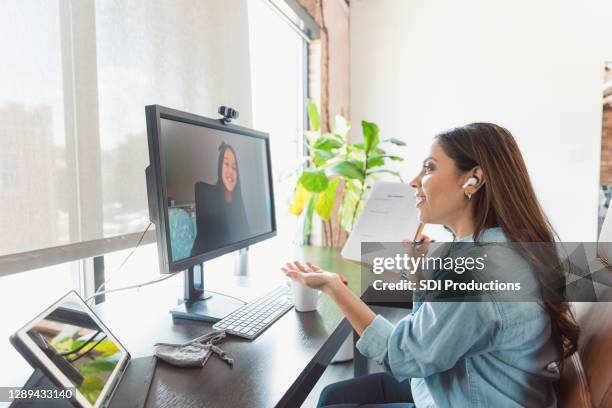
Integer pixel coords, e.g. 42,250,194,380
18,292,128,407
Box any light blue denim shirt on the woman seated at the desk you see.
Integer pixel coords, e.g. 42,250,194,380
357,228,560,408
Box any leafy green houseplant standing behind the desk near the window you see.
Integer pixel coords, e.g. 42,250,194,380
289,100,406,242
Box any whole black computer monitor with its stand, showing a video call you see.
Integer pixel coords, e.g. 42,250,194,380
145,105,276,321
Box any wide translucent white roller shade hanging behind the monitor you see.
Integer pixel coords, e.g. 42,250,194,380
0,0,252,269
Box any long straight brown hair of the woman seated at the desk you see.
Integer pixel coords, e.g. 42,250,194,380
435,123,580,364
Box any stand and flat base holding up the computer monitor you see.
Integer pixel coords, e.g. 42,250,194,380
170,264,244,322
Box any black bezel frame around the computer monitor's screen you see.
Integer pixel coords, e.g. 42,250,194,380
145,105,277,273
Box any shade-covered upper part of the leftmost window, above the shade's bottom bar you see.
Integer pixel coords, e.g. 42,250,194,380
0,0,71,255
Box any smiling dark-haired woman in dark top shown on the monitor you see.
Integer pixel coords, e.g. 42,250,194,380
191,143,249,256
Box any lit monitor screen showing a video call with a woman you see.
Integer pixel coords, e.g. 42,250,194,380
159,117,274,262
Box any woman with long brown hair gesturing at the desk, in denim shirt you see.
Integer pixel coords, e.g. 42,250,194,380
282,123,579,408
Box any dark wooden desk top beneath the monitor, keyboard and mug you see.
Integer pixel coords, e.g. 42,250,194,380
96,247,361,408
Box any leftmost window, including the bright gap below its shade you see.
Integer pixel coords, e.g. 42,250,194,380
0,0,80,386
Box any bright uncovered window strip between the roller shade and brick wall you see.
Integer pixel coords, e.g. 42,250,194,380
248,0,307,240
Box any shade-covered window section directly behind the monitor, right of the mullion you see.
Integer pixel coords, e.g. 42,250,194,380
95,0,251,236
